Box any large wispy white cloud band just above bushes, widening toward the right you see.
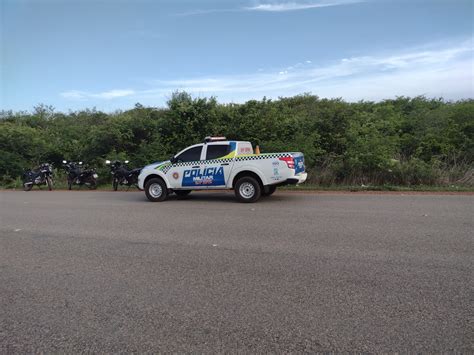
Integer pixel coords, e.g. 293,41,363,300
62,41,474,104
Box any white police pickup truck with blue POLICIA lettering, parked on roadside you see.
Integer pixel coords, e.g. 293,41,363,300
138,137,307,202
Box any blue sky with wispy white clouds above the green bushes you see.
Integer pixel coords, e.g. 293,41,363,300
0,0,474,111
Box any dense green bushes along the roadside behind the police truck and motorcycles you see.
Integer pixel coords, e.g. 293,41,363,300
0,92,474,191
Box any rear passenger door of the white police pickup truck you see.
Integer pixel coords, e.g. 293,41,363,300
202,142,236,189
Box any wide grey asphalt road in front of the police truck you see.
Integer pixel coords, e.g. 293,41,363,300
0,191,474,353
